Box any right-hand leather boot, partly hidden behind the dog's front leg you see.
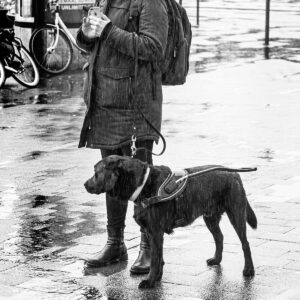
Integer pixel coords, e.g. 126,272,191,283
130,232,151,274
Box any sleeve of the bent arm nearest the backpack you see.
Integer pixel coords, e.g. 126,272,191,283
106,0,168,61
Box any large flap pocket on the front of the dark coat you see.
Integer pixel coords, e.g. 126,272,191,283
96,68,130,108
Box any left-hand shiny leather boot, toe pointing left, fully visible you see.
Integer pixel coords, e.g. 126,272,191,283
86,227,128,268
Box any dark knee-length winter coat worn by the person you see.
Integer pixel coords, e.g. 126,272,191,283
77,0,168,149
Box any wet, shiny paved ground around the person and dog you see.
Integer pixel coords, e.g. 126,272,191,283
0,1,300,300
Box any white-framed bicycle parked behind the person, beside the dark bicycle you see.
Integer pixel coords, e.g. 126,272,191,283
29,1,87,74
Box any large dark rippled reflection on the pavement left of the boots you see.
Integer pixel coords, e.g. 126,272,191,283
3,195,104,262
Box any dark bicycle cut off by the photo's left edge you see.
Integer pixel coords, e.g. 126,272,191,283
0,28,40,88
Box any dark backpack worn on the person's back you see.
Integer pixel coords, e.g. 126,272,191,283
130,0,192,85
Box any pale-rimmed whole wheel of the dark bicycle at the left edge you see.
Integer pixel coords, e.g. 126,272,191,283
12,44,40,87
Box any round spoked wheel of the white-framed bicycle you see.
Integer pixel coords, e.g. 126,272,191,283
29,26,73,74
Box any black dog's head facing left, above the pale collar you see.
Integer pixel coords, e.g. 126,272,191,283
84,155,148,200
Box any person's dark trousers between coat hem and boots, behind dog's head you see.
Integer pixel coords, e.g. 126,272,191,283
101,140,153,231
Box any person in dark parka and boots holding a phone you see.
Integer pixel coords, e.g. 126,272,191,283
77,0,168,274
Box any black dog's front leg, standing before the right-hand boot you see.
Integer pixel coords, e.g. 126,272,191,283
139,231,164,289
